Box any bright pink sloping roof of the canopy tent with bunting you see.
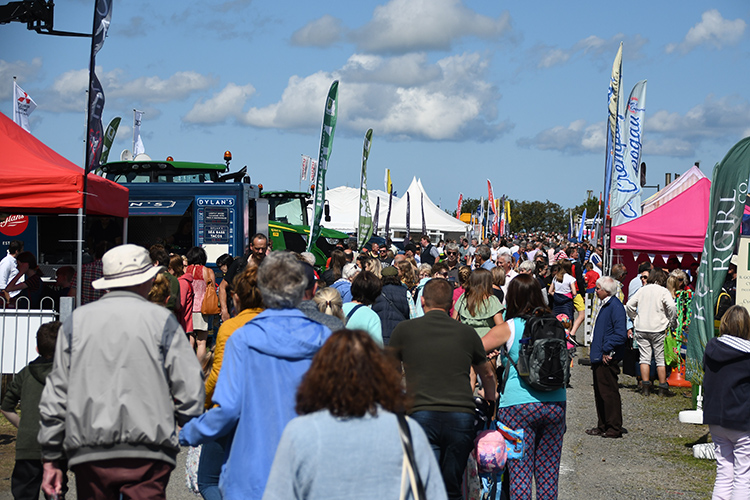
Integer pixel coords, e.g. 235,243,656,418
612,177,711,252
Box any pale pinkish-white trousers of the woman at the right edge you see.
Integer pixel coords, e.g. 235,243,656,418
708,425,750,500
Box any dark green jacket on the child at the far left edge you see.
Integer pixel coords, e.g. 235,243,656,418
2,356,52,460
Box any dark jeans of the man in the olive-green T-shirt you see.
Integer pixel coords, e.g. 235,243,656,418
409,411,476,500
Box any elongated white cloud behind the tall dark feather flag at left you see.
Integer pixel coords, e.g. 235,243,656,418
46,67,216,112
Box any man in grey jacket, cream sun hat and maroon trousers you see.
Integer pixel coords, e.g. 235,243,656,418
39,245,205,498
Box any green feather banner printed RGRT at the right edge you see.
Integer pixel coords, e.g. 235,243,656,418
685,137,750,384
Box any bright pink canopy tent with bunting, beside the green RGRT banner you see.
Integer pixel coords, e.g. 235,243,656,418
611,178,711,296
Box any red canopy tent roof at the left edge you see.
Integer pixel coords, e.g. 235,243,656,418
0,113,128,217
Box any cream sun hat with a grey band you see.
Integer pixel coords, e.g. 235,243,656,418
91,245,164,290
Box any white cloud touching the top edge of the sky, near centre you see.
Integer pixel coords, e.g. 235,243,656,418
352,0,511,54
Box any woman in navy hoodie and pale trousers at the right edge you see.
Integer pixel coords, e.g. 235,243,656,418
703,306,750,500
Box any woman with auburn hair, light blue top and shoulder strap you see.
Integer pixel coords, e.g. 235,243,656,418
263,330,447,500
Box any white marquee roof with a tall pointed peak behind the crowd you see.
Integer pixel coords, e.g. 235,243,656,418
388,177,469,233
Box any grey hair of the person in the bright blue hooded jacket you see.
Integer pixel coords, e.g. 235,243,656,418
258,251,307,309
